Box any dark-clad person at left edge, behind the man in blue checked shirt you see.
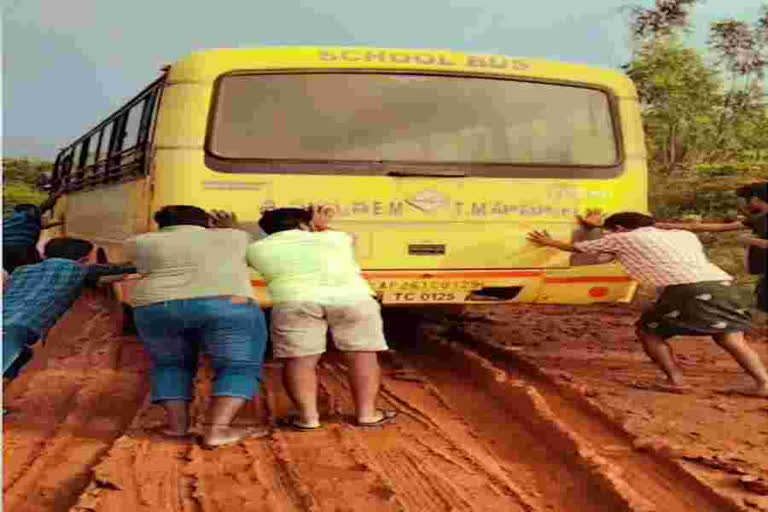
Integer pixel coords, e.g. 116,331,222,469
3,192,62,274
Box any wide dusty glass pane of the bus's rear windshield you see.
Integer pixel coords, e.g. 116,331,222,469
207,72,618,167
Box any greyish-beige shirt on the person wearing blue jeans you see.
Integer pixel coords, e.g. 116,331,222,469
125,226,253,306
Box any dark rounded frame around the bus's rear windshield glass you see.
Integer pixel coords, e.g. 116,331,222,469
203,68,626,179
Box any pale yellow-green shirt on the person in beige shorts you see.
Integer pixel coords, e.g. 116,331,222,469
248,229,373,305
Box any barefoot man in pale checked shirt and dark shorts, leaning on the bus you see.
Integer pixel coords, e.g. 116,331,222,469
528,212,768,397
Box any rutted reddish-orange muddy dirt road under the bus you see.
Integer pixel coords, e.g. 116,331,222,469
3,296,768,512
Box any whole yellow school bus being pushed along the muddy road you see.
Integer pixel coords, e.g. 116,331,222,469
49,47,647,305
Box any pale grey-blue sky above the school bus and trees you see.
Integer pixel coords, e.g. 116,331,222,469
0,0,761,159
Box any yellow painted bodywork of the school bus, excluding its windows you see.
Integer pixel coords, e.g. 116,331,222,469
51,48,648,305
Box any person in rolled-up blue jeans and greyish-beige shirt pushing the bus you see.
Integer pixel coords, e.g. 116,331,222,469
126,205,267,448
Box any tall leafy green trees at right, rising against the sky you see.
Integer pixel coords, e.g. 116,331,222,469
624,0,768,173
